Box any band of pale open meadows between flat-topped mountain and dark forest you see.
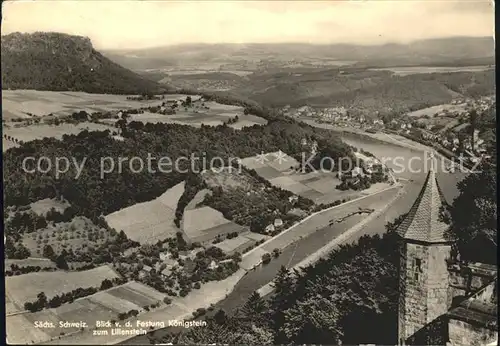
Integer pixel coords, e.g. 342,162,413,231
2,90,267,151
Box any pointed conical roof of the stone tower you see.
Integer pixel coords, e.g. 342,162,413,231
397,156,451,243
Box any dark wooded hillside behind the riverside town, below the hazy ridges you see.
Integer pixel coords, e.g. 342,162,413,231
240,69,495,113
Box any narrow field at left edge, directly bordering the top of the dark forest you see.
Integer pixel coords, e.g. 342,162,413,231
2,122,113,151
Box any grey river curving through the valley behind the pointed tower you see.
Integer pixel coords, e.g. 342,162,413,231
124,132,465,345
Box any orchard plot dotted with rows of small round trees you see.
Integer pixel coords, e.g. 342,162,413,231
22,216,115,257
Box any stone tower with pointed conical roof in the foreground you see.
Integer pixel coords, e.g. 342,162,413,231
397,158,453,345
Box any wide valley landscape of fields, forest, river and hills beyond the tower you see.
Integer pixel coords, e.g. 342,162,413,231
2,32,496,344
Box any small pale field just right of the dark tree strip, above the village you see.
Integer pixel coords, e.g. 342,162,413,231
182,207,246,242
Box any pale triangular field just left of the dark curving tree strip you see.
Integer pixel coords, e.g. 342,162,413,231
105,182,184,244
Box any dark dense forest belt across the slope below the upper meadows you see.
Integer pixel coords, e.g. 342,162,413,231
4,120,352,220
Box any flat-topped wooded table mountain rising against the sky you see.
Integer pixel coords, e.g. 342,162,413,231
1,32,167,94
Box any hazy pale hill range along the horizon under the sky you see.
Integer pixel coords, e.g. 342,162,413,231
103,37,495,71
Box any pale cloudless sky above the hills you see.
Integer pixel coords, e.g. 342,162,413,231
2,0,494,49
